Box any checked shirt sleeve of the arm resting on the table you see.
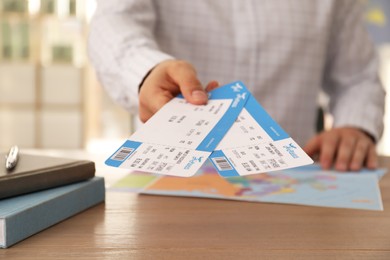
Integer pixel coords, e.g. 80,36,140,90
324,0,385,141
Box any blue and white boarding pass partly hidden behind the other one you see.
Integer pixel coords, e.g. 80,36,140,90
210,96,313,177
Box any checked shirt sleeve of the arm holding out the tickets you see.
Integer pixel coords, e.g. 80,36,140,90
88,0,173,112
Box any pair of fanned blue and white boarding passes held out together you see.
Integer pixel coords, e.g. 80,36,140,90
106,81,313,177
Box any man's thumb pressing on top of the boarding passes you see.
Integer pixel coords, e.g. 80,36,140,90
168,62,208,105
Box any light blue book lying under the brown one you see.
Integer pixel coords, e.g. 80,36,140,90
0,177,105,248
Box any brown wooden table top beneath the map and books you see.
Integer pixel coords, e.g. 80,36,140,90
0,158,390,259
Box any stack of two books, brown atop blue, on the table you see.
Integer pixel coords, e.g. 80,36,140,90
0,153,105,248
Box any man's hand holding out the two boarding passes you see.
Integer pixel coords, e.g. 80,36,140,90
139,60,218,122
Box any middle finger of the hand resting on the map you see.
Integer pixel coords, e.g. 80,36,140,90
335,135,356,171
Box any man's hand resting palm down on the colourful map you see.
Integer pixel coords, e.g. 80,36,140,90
303,127,378,171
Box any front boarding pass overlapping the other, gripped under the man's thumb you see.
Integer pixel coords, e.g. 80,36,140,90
106,82,250,177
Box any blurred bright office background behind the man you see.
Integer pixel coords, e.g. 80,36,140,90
0,0,390,155
